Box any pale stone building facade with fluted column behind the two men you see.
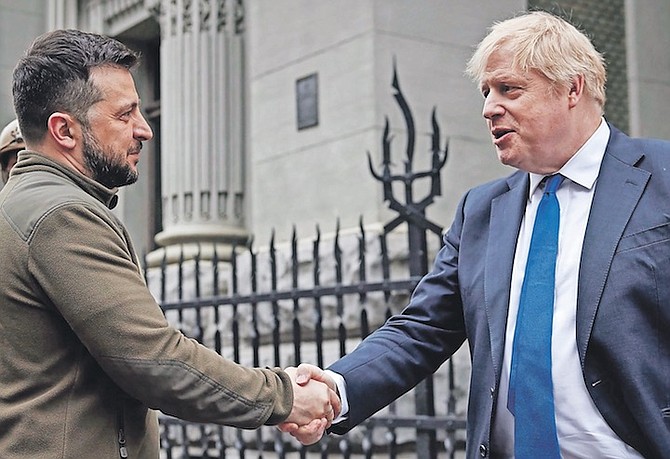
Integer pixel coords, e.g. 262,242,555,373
0,0,670,452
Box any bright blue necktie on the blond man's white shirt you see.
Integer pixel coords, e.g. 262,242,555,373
508,174,563,459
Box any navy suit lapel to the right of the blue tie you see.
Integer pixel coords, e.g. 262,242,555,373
577,126,650,365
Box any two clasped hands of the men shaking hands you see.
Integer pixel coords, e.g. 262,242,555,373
277,363,342,445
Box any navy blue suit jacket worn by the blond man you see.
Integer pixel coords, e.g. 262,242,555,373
330,126,670,458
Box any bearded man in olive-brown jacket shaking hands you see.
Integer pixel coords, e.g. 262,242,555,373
0,30,339,459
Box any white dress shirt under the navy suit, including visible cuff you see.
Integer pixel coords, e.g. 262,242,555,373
328,119,642,459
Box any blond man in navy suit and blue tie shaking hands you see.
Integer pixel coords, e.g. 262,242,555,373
280,12,670,459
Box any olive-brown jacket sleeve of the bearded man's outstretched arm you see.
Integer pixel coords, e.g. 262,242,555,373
29,204,293,428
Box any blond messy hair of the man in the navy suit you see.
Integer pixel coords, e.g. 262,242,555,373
466,11,607,109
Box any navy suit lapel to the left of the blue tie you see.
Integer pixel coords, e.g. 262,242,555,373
484,173,528,384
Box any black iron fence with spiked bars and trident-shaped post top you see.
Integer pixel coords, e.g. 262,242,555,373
147,66,468,459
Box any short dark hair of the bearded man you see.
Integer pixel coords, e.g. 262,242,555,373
12,29,139,142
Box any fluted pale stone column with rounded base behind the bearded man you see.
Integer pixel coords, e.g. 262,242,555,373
154,0,249,258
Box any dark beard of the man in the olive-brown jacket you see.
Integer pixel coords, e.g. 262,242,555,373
83,128,142,188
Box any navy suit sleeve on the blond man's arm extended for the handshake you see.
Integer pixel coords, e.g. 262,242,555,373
329,197,466,434
